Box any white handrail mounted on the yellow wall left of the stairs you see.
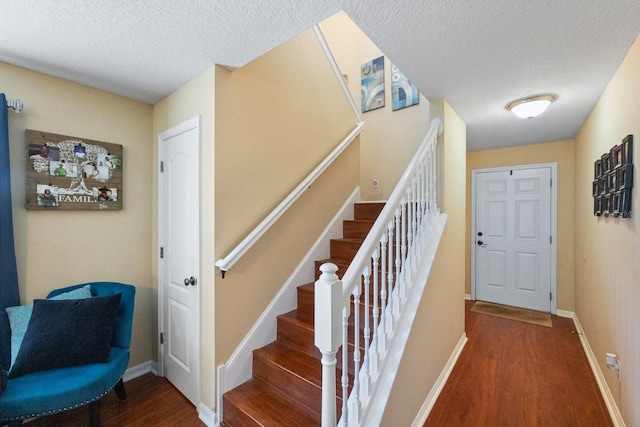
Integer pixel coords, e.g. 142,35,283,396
215,122,365,278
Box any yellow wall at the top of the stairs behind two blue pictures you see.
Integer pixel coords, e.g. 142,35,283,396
320,13,429,200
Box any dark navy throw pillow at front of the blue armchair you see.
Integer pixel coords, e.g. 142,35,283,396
9,294,122,378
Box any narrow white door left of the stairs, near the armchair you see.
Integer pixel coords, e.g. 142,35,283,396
158,117,200,406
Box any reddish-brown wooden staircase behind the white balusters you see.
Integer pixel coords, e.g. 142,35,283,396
221,203,384,427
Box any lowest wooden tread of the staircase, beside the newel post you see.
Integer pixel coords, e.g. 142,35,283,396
224,379,320,427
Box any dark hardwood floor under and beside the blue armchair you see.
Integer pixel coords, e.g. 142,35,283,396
24,374,205,427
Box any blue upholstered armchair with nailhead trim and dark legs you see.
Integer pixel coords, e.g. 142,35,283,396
0,282,135,426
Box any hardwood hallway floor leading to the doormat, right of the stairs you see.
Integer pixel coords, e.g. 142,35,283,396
424,301,613,427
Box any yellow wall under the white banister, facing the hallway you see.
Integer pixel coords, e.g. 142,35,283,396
381,101,466,426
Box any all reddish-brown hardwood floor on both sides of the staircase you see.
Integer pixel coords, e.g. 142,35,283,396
18,301,613,427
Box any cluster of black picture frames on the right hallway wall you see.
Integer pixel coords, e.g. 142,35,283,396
591,135,633,218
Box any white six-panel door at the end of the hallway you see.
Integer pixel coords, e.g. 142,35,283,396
472,167,552,312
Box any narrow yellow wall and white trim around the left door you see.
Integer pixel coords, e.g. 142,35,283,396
149,68,216,408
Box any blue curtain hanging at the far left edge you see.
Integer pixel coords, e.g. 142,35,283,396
0,93,20,369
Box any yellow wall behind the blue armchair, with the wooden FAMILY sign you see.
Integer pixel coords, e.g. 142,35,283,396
0,63,154,366
